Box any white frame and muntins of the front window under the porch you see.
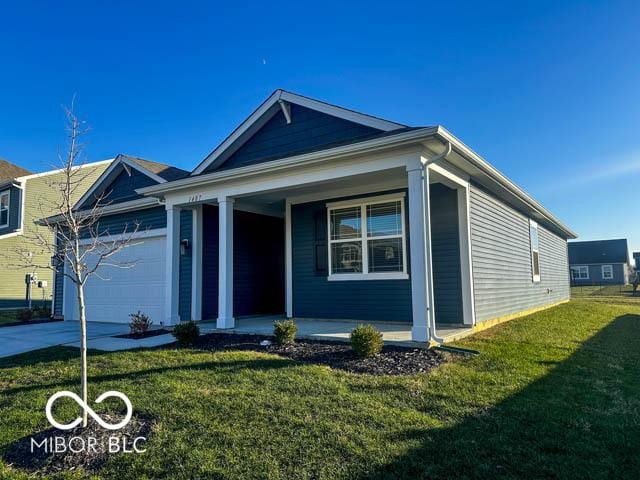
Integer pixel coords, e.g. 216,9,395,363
327,193,409,281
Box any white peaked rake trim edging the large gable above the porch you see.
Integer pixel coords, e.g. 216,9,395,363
191,90,406,176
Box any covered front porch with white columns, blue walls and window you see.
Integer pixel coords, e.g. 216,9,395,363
166,144,474,346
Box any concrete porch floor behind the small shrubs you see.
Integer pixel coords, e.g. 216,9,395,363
200,315,472,346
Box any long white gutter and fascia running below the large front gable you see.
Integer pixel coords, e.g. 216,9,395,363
143,127,437,196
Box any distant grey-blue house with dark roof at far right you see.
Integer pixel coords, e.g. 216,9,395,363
569,238,632,285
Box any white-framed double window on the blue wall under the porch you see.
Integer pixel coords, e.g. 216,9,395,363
327,195,408,280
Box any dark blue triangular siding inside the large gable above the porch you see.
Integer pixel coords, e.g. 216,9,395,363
208,104,380,173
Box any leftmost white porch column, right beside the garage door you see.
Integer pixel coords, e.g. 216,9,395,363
164,205,180,325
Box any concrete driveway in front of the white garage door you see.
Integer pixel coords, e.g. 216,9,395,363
0,321,129,357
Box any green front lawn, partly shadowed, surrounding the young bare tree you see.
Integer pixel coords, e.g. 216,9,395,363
0,300,640,479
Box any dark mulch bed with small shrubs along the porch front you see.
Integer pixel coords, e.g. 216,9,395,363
181,333,458,375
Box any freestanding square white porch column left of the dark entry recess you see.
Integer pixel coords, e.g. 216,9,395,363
216,197,234,328
